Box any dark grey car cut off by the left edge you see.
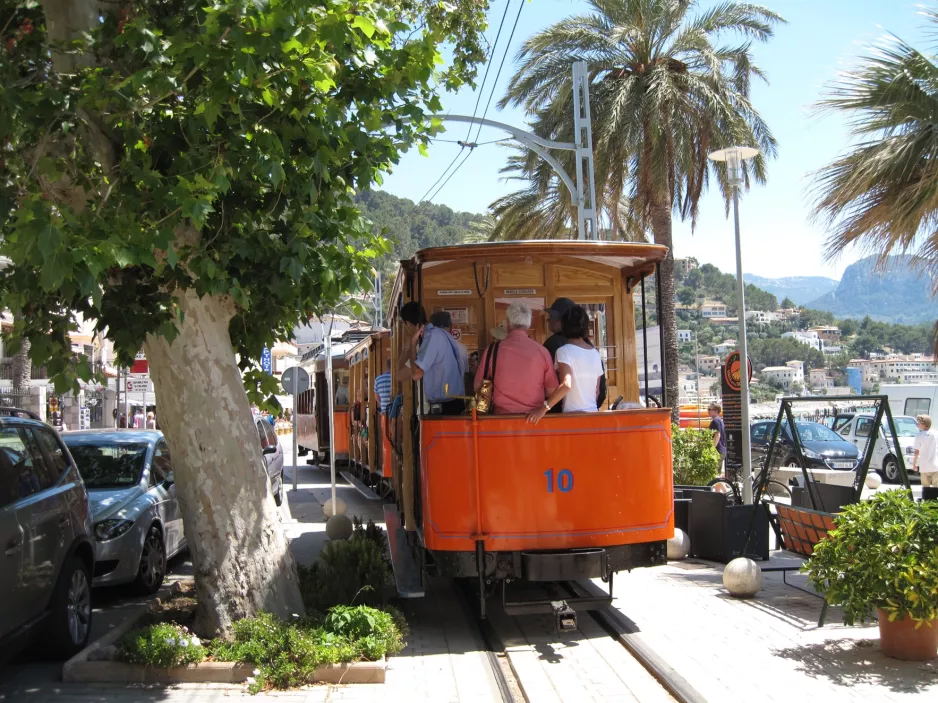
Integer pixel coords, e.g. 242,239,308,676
0,408,94,660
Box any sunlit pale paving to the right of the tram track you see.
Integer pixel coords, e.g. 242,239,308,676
600,559,938,703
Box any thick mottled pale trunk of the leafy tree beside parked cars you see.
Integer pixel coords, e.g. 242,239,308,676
145,289,303,634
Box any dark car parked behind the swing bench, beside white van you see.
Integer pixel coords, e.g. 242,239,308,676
749,421,859,471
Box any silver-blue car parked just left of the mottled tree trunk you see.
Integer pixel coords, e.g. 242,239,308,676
63,430,186,594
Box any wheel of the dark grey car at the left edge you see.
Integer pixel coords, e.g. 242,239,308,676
49,556,91,659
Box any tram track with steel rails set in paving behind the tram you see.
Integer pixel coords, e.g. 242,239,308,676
456,579,706,703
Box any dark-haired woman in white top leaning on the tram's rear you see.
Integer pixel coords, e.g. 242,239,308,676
528,305,603,424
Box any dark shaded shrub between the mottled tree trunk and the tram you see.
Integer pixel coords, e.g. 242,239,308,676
299,530,394,612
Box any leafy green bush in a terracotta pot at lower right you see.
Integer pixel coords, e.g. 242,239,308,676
804,490,938,661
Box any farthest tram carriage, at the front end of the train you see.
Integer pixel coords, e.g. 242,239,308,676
296,329,371,463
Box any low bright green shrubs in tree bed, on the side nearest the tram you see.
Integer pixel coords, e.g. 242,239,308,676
211,606,404,692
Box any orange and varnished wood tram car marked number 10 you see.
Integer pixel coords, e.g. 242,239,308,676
384,241,674,629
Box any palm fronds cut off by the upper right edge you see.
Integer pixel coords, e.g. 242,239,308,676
815,9,938,310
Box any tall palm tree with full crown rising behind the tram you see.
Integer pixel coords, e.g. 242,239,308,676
500,0,783,413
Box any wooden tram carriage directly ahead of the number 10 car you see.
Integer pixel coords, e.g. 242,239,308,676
345,330,393,498
